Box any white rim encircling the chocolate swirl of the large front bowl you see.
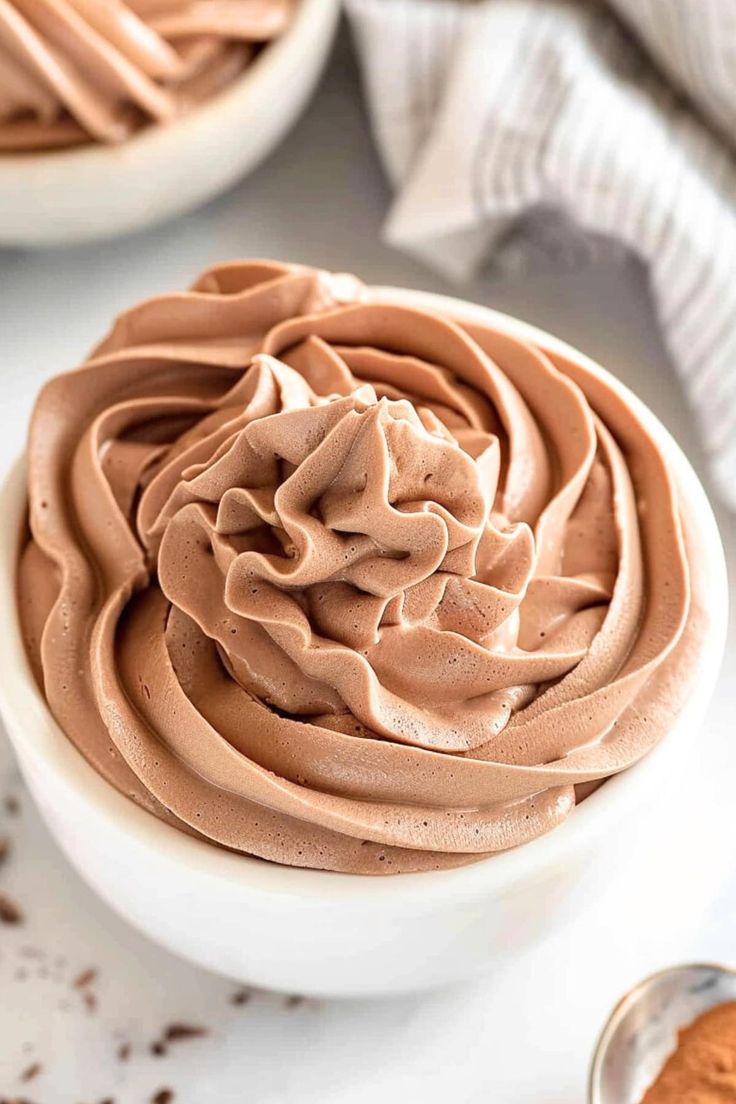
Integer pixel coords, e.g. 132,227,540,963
0,286,728,909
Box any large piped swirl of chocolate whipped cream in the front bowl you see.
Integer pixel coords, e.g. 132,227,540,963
19,262,704,873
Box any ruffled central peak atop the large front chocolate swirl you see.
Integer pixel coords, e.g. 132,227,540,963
147,357,536,751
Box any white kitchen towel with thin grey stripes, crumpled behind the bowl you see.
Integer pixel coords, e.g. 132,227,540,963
346,0,736,508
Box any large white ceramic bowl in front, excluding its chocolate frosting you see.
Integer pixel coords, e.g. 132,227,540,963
0,289,728,996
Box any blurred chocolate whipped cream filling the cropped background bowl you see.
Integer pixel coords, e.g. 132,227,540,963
0,0,296,152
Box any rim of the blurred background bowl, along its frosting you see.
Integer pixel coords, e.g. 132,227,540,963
0,0,340,167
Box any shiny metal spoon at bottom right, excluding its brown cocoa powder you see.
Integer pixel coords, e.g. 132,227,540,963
588,964,736,1104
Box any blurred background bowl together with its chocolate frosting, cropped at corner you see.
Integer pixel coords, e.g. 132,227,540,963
0,0,339,245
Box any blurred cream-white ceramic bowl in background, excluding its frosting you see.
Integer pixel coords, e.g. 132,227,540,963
0,0,340,246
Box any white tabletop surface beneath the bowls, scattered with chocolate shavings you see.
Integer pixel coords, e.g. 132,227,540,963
0,25,736,1104
